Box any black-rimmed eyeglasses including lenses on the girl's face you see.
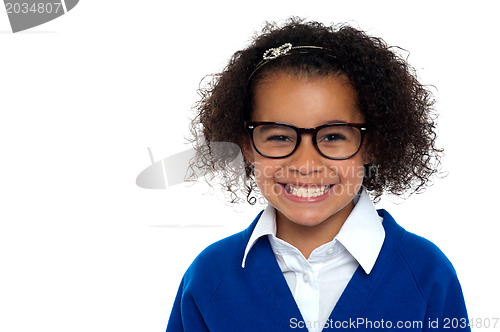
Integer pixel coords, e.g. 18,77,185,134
245,121,368,160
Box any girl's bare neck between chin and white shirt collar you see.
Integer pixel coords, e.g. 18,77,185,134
276,202,354,259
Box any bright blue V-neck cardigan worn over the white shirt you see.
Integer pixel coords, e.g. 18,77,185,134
167,210,470,332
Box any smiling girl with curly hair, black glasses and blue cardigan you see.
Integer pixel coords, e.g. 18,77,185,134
167,19,470,332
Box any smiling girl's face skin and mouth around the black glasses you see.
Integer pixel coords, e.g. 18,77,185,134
244,73,365,226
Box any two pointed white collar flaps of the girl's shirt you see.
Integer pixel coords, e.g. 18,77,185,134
241,189,385,274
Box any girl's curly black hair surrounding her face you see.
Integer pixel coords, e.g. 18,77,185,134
191,18,442,204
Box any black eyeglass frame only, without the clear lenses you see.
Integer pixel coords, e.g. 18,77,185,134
244,121,368,160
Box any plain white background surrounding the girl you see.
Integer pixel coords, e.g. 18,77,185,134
0,0,500,332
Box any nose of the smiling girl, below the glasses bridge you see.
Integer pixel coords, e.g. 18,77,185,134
288,134,323,175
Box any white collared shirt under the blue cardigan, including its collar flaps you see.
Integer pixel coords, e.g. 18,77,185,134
242,189,385,332
